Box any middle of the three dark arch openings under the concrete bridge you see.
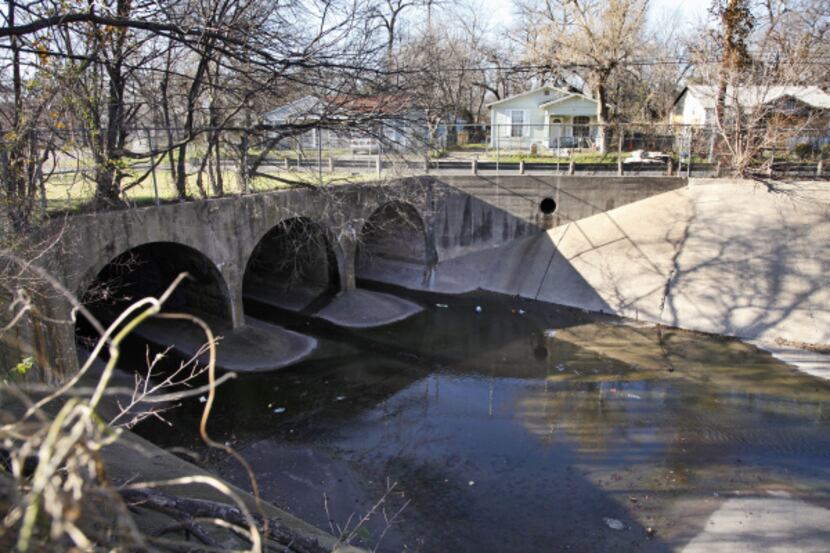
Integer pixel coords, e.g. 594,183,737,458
242,217,343,310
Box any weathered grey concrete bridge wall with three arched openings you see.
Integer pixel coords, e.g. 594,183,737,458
3,175,685,374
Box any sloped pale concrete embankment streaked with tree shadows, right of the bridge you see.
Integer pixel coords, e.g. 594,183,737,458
410,180,830,368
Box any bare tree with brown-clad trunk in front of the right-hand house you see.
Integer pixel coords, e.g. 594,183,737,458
692,0,830,176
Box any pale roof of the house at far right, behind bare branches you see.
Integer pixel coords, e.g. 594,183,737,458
675,85,830,109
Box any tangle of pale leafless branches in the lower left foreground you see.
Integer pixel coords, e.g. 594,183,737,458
0,275,332,552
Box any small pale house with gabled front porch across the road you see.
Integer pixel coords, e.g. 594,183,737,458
487,86,597,150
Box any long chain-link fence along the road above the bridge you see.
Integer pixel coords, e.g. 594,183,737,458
8,121,830,210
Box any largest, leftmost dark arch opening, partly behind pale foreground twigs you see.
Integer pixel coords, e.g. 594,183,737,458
76,241,235,324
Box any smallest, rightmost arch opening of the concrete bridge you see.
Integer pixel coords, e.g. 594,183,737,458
355,201,437,281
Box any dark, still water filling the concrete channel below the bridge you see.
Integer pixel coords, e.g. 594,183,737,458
140,288,830,552
